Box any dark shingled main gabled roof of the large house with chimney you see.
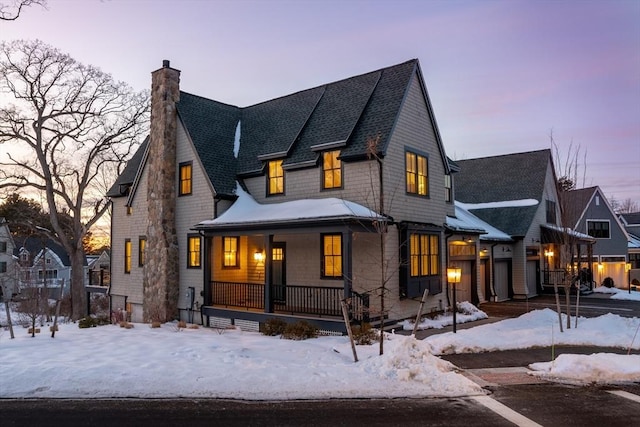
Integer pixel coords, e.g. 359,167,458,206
107,59,450,203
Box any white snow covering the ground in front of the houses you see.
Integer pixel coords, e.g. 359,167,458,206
0,292,640,400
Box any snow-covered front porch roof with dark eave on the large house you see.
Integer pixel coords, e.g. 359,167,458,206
194,185,389,230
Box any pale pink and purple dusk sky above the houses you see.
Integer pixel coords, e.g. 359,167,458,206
0,0,640,203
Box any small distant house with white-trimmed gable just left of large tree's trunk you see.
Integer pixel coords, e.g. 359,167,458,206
13,235,71,294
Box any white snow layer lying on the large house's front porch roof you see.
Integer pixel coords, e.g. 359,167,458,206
198,183,387,227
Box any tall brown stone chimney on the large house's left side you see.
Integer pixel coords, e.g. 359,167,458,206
143,60,180,322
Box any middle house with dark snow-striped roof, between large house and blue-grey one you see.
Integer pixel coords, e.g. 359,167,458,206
453,149,593,301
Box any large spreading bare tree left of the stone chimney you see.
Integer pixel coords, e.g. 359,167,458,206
0,40,149,320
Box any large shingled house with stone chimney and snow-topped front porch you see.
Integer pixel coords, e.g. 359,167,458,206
108,59,455,330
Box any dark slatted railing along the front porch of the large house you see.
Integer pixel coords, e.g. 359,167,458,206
211,281,369,321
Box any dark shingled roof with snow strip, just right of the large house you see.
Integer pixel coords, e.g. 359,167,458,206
455,149,551,237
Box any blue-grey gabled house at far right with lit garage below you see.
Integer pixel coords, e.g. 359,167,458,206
563,186,629,288
